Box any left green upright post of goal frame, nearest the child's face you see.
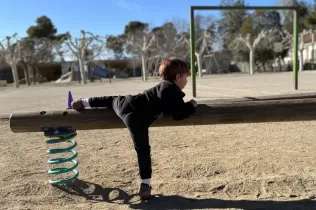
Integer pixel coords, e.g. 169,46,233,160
190,7,196,97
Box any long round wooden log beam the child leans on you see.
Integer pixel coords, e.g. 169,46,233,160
0,93,316,133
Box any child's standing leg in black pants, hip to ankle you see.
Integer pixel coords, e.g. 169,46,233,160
100,96,152,179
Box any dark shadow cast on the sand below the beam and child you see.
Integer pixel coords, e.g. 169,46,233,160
56,180,316,210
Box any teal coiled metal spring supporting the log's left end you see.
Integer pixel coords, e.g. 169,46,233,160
43,127,79,184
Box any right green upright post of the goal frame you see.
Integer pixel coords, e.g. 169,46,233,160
292,9,298,90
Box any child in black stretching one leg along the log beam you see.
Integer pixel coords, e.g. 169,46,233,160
72,57,197,200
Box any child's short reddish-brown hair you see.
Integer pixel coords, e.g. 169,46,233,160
159,57,190,82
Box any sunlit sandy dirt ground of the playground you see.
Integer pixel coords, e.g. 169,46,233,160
0,72,316,210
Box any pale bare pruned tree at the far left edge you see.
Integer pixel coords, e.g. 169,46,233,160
0,33,21,88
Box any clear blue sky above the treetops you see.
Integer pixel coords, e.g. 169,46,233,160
0,0,312,39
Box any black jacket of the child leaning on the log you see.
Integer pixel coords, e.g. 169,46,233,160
89,81,195,121
